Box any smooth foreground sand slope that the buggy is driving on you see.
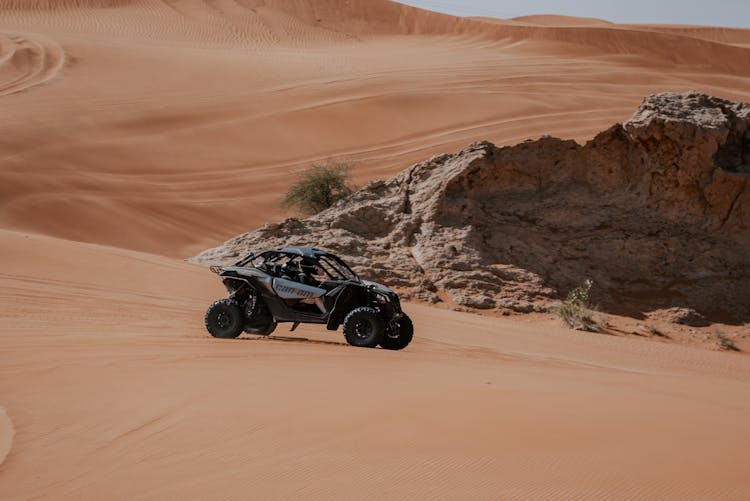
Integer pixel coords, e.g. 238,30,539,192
0,232,750,499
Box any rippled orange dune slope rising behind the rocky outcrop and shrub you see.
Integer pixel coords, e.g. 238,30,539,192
0,0,750,256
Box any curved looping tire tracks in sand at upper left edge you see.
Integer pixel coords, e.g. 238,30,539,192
0,32,65,96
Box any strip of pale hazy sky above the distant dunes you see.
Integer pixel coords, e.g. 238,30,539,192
398,0,750,28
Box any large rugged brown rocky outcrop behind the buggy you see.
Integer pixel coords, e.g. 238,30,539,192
195,93,750,320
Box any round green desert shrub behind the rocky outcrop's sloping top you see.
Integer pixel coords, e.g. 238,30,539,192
281,163,354,215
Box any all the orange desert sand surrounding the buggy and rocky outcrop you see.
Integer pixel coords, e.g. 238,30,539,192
0,0,750,499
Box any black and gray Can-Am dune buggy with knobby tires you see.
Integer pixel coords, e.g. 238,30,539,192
205,247,414,350
